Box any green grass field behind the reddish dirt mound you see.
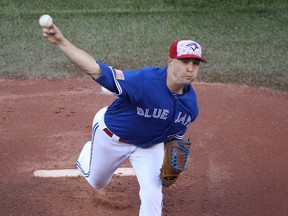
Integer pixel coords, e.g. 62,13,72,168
0,0,288,91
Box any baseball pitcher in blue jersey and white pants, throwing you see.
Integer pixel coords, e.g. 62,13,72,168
43,20,207,216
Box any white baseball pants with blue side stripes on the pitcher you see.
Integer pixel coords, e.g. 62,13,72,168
77,108,164,216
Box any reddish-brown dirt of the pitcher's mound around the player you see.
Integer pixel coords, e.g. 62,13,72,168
0,78,288,216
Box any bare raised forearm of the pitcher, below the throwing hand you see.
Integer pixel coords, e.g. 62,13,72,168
57,39,101,79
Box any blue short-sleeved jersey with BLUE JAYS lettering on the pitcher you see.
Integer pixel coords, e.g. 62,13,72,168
96,62,199,148
